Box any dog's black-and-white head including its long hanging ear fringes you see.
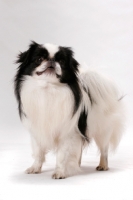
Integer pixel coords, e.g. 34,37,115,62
14,42,81,116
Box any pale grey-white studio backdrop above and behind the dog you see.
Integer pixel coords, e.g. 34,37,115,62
0,0,133,134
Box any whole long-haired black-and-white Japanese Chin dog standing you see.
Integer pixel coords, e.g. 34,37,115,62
14,42,124,179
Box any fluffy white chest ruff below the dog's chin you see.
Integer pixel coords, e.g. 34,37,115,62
21,77,73,138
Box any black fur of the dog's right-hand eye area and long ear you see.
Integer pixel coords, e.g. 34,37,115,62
55,47,82,113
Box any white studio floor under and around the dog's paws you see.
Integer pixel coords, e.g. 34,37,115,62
0,130,133,200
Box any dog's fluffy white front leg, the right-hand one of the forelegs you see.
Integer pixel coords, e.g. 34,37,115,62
52,133,82,179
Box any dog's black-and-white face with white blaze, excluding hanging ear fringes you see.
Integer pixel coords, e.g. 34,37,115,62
17,42,78,84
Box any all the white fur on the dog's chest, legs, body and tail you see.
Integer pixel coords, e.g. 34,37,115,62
21,67,124,178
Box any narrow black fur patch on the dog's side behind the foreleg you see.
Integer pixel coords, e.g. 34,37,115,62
78,108,89,142
